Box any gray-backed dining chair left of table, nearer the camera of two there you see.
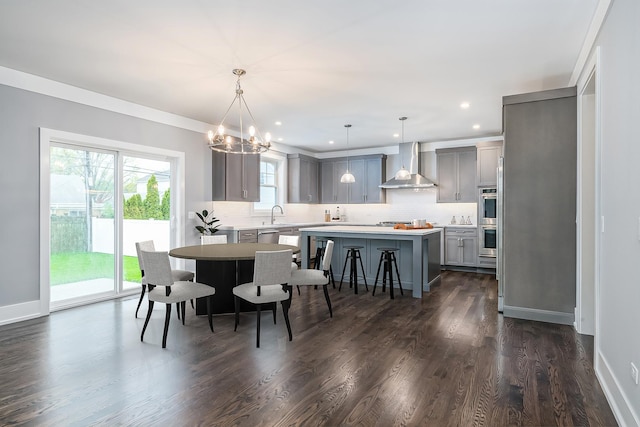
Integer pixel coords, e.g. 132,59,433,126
140,251,216,348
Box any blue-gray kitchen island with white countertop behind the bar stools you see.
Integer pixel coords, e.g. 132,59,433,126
300,225,442,298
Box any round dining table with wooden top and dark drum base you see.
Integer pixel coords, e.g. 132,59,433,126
169,243,300,315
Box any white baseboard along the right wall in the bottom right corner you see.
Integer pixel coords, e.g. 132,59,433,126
595,352,640,427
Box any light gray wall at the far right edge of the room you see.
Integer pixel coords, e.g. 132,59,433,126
592,0,640,425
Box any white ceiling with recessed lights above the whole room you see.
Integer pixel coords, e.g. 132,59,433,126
0,0,598,152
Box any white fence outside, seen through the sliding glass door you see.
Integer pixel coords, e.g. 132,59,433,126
92,218,171,256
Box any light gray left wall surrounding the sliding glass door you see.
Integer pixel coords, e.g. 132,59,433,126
0,85,211,308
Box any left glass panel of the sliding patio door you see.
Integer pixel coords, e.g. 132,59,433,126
49,145,117,307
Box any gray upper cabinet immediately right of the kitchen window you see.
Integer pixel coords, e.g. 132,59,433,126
287,154,320,203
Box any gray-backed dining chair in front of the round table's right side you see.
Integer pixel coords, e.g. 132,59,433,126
233,249,293,347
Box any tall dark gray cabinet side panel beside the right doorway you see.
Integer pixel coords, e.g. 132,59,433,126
499,87,578,324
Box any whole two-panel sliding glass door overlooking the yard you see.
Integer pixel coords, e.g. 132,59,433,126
49,143,172,309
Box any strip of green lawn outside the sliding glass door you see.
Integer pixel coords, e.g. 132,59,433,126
50,252,140,286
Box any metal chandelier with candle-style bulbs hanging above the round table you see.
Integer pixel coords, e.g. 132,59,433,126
207,68,271,154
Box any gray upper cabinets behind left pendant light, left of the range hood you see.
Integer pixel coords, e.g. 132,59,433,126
320,155,386,204
